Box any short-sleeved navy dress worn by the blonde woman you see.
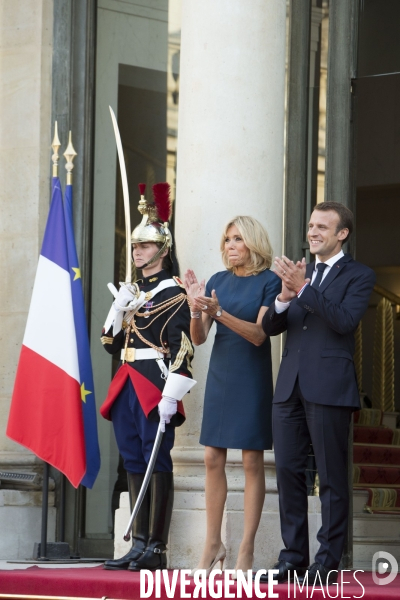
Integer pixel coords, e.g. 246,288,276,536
200,269,282,450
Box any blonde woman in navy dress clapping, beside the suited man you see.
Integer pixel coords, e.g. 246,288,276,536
185,216,281,574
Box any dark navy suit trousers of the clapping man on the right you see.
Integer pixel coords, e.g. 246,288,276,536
272,382,352,569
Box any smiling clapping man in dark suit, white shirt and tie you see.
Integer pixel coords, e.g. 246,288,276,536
262,202,375,585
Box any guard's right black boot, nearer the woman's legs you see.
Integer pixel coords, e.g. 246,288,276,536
128,473,174,571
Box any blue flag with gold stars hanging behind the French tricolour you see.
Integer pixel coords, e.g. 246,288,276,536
64,185,100,488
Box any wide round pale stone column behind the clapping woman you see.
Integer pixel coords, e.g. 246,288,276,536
170,0,286,568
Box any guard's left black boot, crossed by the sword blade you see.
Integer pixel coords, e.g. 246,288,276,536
104,473,150,571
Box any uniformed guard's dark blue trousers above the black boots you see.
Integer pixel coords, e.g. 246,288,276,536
111,378,175,473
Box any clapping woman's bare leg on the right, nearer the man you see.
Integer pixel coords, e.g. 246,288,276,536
235,450,265,571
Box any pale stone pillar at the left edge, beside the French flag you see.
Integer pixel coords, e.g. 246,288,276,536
0,0,55,559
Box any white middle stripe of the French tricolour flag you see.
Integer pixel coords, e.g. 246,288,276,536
23,255,79,382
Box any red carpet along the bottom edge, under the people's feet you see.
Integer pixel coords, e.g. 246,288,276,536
0,566,400,600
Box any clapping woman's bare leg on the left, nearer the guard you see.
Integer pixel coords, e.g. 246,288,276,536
197,446,227,569
